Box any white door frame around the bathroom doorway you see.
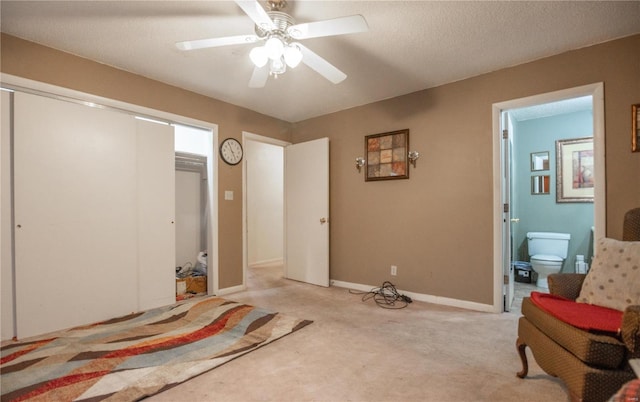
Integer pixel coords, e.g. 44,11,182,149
492,82,607,313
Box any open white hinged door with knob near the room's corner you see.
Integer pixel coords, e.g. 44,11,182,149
284,138,329,286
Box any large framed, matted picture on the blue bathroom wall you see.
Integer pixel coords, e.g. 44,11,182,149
556,137,595,203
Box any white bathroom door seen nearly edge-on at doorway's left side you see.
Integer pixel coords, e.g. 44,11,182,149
502,112,514,311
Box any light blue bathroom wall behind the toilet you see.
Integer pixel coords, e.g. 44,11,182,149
511,111,594,272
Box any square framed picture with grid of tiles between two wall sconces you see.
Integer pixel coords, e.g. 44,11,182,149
364,129,409,181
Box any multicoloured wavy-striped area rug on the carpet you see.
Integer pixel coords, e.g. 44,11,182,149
0,297,311,401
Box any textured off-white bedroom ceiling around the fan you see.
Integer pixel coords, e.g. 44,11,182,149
0,0,640,122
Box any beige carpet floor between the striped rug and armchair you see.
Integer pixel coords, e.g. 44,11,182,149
148,267,568,402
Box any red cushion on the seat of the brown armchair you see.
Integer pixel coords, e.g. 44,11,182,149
531,292,622,334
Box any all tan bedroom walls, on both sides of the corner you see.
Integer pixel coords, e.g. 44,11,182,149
1,35,640,304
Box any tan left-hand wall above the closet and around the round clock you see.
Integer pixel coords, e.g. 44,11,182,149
0,34,291,289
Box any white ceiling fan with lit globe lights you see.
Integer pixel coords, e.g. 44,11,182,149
176,0,369,88
